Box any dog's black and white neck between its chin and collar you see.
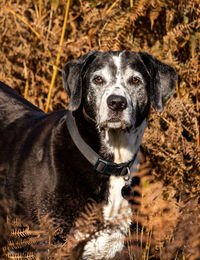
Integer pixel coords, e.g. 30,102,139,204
72,109,146,163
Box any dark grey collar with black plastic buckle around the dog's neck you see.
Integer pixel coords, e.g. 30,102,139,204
66,111,137,176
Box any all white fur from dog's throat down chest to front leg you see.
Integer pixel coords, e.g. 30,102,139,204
83,120,146,260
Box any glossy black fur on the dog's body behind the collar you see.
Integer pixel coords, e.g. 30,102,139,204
0,83,108,239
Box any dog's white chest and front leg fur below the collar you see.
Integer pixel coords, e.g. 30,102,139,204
83,152,131,260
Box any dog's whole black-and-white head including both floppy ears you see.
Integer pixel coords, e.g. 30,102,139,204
63,51,177,130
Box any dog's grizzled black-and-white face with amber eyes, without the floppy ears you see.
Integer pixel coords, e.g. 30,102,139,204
83,52,150,129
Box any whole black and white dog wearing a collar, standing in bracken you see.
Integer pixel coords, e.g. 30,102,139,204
0,51,177,259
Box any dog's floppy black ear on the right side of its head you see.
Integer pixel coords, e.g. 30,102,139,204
139,52,177,112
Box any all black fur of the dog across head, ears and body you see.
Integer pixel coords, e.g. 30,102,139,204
0,51,176,247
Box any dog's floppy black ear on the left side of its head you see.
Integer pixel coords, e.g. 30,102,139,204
62,51,98,111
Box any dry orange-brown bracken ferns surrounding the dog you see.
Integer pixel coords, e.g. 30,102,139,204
0,0,200,260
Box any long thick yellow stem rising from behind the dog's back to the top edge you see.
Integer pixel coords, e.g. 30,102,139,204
45,0,70,113
